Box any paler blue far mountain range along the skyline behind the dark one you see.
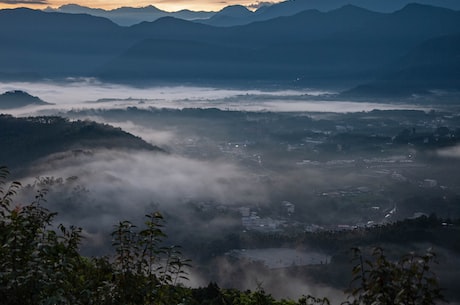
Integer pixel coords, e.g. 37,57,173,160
45,0,460,26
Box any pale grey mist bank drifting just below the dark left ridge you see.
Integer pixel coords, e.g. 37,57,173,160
20,150,268,251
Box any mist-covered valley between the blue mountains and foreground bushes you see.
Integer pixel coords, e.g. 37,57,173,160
0,82,460,299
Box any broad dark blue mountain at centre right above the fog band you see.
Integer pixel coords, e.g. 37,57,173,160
99,5,460,85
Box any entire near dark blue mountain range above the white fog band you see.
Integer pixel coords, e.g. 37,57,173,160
0,4,460,93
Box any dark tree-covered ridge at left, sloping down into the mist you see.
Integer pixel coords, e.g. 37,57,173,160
0,114,161,169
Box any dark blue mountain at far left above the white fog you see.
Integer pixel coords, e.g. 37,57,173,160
0,8,121,79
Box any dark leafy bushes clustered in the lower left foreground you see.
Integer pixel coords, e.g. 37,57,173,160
0,167,190,305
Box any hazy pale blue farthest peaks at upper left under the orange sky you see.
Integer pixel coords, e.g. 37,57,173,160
45,4,215,26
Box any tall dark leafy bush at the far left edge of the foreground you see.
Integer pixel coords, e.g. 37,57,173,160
0,167,81,305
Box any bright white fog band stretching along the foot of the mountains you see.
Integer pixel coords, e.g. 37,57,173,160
0,79,424,116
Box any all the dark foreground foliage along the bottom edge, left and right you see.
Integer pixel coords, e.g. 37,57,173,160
0,167,443,305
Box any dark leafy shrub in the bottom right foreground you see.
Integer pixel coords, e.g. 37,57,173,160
343,248,444,305
